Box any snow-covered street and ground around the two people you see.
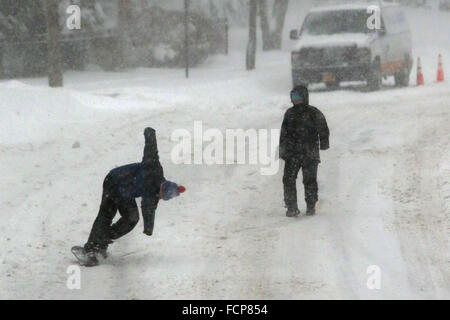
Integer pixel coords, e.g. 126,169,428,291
0,6,450,299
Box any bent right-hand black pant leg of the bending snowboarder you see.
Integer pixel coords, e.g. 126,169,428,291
111,199,139,240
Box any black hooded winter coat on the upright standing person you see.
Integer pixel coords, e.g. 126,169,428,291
280,92,330,163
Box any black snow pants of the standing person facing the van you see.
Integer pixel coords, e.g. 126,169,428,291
283,158,319,209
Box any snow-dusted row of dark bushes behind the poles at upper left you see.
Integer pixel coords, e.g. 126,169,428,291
0,0,229,77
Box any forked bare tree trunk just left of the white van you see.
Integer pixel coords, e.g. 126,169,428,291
259,0,289,51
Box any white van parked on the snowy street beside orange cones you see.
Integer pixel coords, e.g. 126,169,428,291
291,2,412,90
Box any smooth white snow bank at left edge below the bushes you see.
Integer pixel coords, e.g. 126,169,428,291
0,81,125,146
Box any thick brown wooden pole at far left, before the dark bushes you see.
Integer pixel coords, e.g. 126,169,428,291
46,0,63,88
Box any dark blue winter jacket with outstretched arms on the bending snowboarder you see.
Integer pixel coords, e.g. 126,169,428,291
109,128,165,234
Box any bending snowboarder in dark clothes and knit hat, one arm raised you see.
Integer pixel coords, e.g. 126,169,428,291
72,128,185,266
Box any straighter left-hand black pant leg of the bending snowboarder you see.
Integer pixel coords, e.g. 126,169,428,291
85,175,119,250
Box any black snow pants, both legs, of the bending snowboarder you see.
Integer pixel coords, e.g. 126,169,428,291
84,175,139,251
